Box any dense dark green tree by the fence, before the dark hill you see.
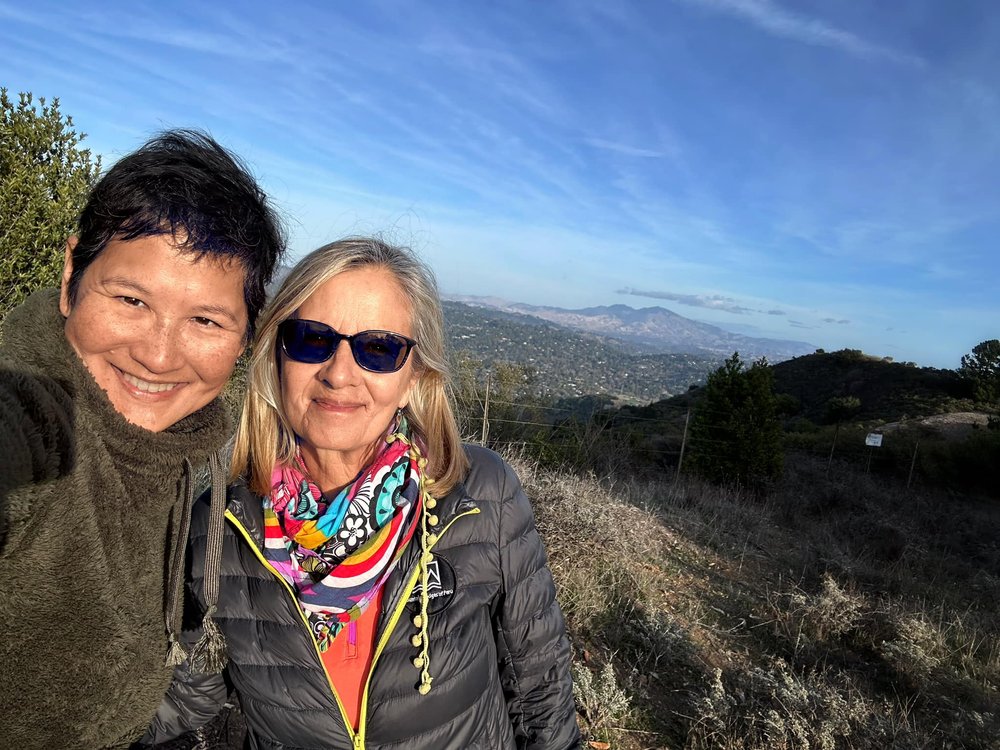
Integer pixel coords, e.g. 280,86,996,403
689,352,784,491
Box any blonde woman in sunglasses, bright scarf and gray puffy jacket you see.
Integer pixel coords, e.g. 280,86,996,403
147,238,579,750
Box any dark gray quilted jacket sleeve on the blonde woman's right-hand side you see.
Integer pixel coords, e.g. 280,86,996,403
496,464,580,750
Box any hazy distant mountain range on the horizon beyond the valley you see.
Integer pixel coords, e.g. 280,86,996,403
447,295,816,362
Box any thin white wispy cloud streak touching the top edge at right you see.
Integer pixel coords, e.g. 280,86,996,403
686,0,925,68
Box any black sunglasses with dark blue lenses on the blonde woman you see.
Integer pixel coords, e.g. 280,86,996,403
278,319,417,372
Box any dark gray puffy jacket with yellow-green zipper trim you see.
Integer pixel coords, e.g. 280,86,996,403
147,446,580,750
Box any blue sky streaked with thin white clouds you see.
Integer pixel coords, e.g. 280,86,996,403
0,0,1000,367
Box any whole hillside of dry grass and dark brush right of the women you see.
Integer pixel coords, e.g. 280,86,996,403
456,351,1000,750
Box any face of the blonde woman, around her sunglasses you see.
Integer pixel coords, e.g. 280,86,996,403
281,267,417,490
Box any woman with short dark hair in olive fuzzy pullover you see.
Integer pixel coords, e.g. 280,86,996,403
0,130,284,750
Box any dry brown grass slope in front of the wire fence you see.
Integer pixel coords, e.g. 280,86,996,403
511,456,1000,750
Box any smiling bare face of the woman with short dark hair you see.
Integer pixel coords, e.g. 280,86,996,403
59,235,247,432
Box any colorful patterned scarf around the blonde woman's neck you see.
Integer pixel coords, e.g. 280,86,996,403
263,417,421,651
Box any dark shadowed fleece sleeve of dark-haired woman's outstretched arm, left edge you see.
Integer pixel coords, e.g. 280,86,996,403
0,362,75,547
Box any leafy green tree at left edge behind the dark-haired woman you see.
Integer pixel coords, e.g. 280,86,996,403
0,88,101,318
